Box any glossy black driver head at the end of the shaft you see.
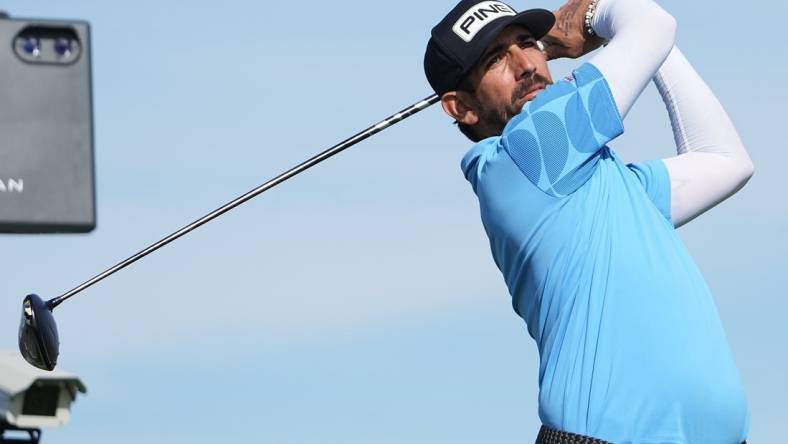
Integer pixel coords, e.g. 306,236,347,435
19,294,60,371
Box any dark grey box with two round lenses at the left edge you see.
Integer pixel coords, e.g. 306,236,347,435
0,14,96,233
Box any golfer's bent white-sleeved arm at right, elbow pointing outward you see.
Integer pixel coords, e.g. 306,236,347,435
654,48,754,227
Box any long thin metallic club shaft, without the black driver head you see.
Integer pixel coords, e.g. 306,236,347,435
47,95,440,309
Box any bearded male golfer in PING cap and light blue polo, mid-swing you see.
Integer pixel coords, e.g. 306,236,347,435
424,0,753,444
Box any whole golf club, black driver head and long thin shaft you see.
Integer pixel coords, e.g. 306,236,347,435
19,94,440,371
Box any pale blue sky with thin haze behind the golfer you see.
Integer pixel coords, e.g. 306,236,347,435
0,0,788,443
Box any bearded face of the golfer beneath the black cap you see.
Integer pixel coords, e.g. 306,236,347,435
447,25,553,137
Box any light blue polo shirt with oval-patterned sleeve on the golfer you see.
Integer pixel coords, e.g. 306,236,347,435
462,63,749,444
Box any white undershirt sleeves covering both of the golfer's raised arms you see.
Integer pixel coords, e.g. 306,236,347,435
590,0,753,227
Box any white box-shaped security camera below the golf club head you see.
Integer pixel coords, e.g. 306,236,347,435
0,351,87,434
